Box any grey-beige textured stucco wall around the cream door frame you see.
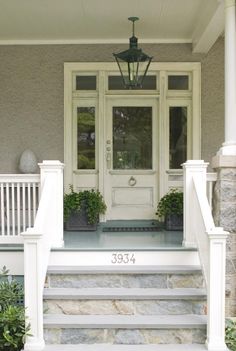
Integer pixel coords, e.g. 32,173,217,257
0,39,224,173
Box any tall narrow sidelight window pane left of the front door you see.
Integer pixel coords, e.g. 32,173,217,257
77,107,95,169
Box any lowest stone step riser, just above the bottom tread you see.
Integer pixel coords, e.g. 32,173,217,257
44,328,206,345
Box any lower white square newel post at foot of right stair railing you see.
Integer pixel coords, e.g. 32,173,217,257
206,228,228,351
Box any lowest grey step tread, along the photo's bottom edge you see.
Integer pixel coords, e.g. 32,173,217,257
44,344,206,351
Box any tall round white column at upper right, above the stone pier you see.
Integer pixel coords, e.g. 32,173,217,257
219,0,236,155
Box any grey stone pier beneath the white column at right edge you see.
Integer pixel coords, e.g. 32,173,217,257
214,162,236,317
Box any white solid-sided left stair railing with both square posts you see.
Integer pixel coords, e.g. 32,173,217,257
21,161,64,351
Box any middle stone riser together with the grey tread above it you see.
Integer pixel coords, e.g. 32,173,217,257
44,288,206,315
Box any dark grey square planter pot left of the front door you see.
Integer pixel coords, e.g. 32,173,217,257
64,208,97,232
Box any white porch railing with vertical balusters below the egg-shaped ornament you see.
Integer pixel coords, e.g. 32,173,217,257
0,174,40,244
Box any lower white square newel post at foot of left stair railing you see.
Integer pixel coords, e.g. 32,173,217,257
21,228,45,351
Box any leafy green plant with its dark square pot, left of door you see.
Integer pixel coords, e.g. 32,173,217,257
64,185,106,231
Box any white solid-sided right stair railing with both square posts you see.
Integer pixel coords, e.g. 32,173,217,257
183,161,228,351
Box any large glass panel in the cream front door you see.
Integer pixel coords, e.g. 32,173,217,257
113,106,152,169
